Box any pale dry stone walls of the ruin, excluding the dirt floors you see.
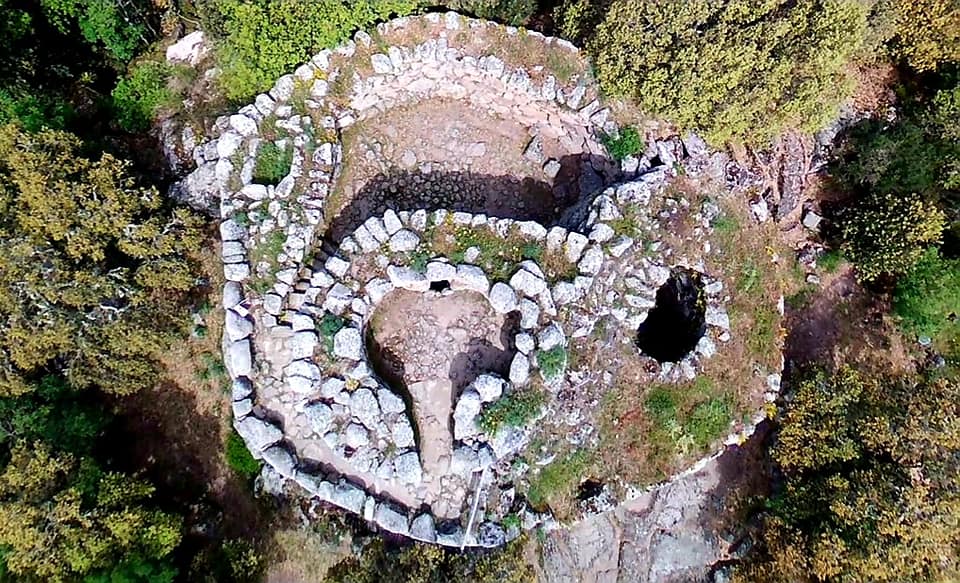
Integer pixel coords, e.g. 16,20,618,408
184,13,779,547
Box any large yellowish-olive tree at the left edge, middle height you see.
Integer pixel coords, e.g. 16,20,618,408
0,126,202,394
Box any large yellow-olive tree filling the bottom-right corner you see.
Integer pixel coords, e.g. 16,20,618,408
738,369,960,583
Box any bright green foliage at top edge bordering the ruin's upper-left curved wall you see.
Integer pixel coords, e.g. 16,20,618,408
206,0,419,101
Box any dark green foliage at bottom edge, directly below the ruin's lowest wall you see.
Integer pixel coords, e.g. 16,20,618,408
323,537,536,583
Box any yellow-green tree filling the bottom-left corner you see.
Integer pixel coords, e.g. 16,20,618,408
0,443,181,582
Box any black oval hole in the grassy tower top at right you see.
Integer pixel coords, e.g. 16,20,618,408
637,269,707,362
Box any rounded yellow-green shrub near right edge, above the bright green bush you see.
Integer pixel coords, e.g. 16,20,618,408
839,194,945,281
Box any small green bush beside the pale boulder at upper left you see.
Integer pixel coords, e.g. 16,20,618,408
111,61,176,132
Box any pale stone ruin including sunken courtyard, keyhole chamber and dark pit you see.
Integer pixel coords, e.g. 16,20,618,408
185,13,784,547
